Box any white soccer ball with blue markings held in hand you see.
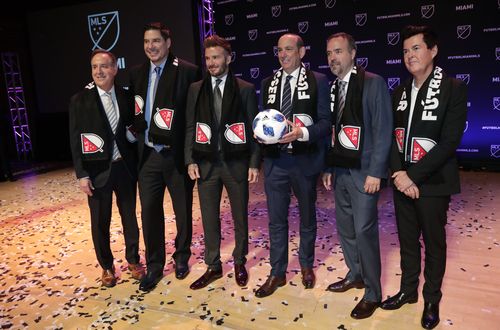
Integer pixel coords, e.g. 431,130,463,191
252,109,288,144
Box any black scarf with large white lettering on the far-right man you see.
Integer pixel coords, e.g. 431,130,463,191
393,66,450,164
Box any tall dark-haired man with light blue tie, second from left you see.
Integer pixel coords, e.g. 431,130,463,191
130,22,198,291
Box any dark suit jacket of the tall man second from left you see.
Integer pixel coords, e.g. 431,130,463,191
130,59,199,173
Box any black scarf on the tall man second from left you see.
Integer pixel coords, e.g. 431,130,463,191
134,52,179,145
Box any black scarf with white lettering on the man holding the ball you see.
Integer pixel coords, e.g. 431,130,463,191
261,63,318,157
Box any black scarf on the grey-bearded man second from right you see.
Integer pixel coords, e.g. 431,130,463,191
326,66,365,168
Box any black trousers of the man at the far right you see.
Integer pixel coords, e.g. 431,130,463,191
394,190,450,303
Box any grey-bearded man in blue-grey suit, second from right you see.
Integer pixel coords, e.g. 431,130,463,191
322,32,392,319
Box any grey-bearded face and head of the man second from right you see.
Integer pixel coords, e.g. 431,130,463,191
326,37,356,79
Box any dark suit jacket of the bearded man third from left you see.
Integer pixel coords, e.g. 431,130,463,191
184,78,261,181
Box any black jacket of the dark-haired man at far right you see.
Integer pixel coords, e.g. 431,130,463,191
391,77,467,196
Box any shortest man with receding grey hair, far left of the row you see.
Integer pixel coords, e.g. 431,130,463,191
69,50,144,287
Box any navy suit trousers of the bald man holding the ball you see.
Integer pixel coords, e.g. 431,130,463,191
264,152,318,277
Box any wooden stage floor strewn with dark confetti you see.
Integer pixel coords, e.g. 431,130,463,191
0,169,500,329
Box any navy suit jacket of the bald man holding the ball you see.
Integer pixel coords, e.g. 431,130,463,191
261,71,332,176
